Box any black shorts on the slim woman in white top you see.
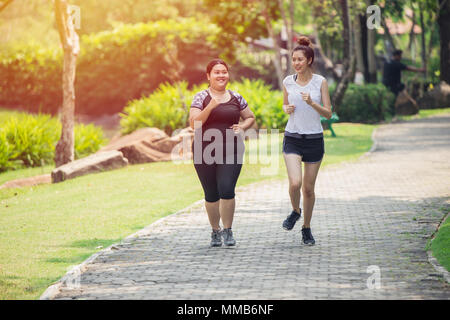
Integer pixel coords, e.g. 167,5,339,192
283,136,325,163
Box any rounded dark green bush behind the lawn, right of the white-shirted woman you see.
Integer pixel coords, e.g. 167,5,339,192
337,83,395,123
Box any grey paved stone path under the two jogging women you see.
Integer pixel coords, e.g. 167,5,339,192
47,115,450,299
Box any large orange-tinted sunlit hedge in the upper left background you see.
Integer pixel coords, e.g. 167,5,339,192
0,19,219,114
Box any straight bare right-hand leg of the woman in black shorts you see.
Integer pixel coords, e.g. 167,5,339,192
302,161,322,228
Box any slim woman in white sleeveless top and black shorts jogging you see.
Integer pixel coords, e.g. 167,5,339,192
283,36,331,245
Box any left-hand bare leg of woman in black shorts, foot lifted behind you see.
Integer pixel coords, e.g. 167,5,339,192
283,153,302,213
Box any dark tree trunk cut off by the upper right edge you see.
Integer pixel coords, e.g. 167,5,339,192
438,0,450,84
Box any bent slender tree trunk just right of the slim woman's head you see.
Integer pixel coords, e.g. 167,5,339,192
331,0,356,112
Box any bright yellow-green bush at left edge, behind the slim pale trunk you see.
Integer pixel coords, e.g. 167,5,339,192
0,113,106,172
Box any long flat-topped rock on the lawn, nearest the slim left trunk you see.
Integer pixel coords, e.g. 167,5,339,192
51,150,128,183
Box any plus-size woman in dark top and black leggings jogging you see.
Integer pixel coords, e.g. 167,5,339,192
189,59,255,247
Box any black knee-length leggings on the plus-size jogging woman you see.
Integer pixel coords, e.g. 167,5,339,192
194,163,242,202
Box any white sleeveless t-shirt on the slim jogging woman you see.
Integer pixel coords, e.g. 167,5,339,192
283,73,325,134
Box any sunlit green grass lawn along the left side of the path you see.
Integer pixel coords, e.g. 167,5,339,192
0,124,375,299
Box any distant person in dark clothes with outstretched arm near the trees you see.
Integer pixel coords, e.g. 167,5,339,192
383,50,425,100
